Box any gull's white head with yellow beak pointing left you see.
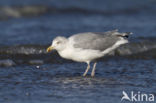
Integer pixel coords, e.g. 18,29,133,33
47,36,68,52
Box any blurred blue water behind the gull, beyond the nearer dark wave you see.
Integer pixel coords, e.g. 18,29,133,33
0,0,156,45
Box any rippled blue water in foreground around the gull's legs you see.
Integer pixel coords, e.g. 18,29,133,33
0,59,156,103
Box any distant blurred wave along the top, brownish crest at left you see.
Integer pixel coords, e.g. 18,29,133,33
0,2,156,20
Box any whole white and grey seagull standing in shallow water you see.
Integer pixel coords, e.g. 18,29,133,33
47,30,131,77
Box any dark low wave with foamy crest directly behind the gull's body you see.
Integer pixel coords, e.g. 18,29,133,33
0,41,156,66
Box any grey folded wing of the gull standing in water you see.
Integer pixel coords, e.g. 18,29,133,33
73,32,119,51
